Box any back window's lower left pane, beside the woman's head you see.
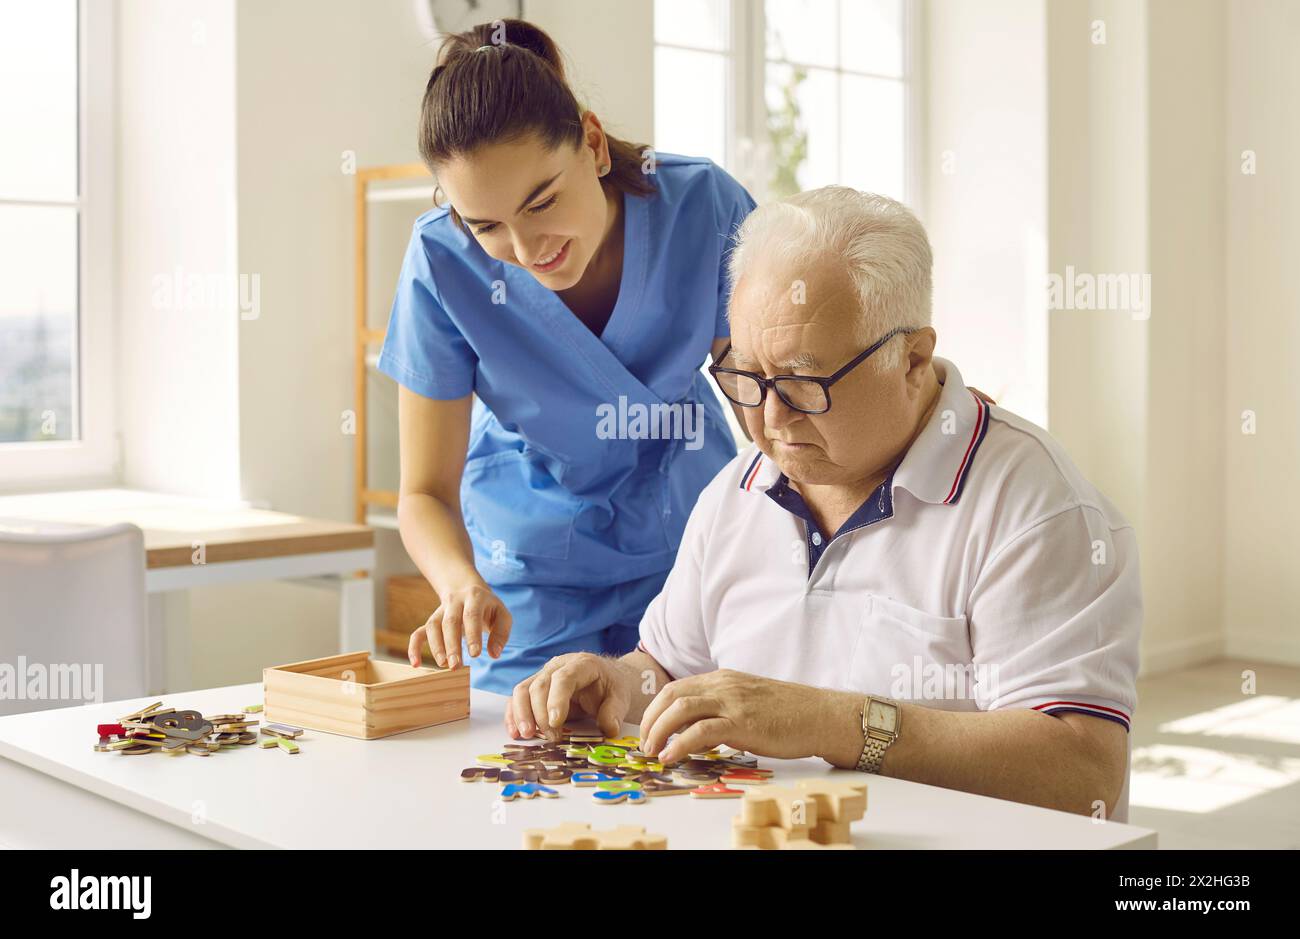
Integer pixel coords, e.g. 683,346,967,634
654,47,727,166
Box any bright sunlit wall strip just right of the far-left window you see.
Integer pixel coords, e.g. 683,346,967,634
114,0,239,498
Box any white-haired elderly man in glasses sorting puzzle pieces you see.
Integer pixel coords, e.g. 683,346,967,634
506,187,1141,818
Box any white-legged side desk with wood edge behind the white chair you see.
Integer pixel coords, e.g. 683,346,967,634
0,489,374,694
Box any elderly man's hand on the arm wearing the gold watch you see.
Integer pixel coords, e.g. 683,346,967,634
641,668,826,762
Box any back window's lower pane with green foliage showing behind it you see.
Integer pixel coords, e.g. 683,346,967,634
766,65,840,199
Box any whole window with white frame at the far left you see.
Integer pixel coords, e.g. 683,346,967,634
0,0,114,488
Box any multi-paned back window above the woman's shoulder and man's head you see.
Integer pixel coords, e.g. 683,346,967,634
655,0,919,207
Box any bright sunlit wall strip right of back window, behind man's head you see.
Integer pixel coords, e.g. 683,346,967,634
920,0,1048,425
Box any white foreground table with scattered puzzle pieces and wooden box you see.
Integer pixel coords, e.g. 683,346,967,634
0,683,1156,849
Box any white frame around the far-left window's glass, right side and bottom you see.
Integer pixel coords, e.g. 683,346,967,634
0,0,121,492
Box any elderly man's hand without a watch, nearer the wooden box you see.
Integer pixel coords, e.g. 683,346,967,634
506,652,633,740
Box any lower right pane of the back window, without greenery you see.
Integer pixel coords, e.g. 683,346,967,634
839,74,906,202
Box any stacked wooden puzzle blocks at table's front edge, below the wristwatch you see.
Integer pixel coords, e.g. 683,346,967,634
732,779,867,851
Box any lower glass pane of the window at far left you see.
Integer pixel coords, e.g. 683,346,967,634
0,205,77,442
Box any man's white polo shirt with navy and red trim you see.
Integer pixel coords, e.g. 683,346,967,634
641,358,1141,730
